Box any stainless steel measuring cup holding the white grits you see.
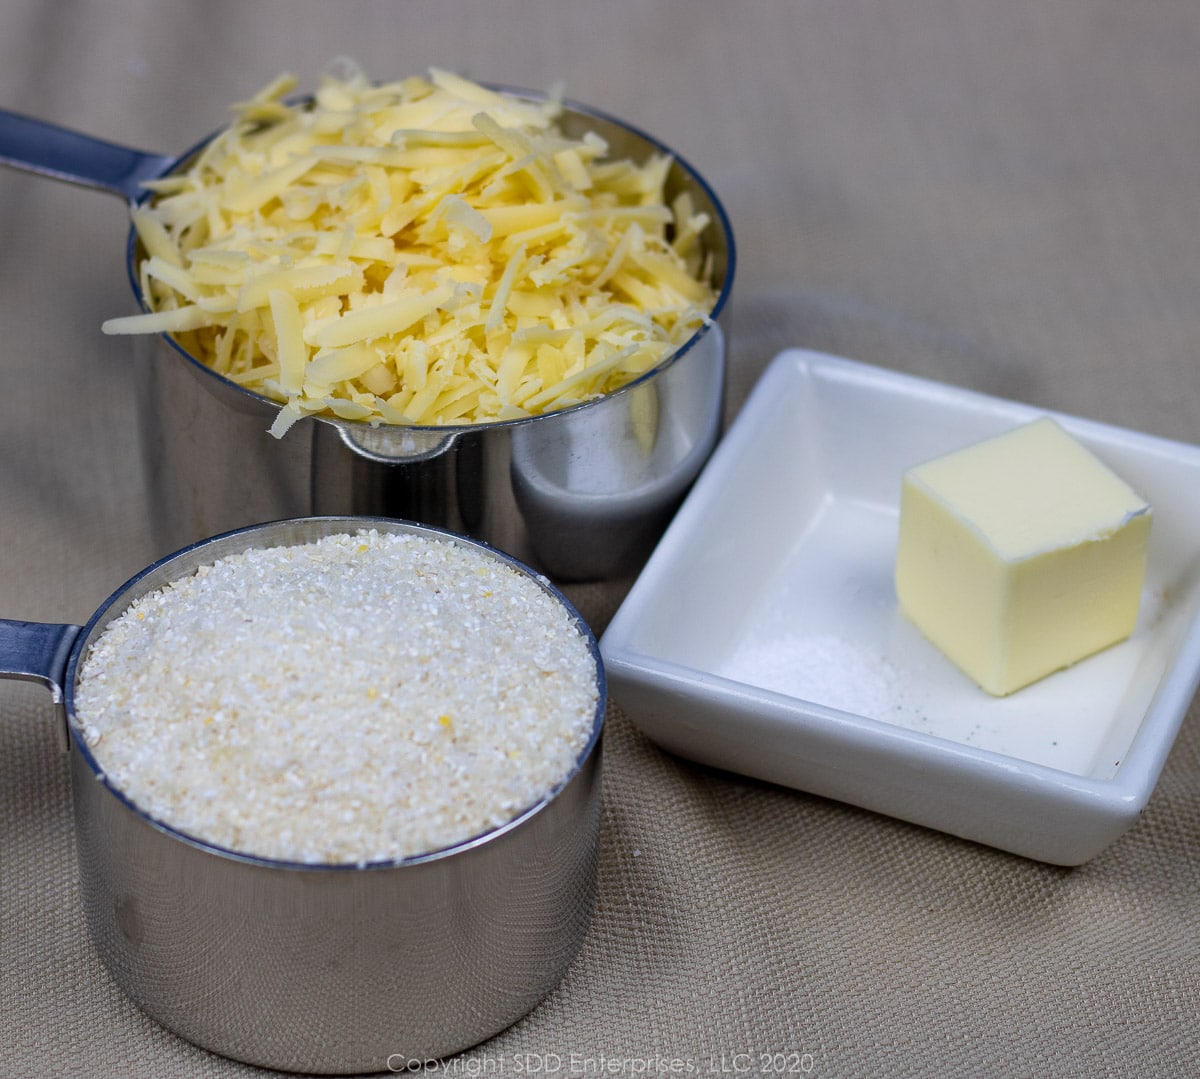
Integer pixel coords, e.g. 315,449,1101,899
0,517,605,1073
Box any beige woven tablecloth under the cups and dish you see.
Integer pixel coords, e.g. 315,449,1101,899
0,0,1200,1077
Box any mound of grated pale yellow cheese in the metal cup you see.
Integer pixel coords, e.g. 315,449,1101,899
103,64,715,437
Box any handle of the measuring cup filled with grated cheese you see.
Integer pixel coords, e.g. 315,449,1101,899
0,109,173,203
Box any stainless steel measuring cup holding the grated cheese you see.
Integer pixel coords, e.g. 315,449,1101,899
0,88,736,580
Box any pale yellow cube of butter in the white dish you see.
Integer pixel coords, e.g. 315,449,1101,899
895,418,1151,696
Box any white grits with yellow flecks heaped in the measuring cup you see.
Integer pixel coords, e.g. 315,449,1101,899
74,529,600,864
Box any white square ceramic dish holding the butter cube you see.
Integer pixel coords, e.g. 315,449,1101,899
600,349,1200,865
